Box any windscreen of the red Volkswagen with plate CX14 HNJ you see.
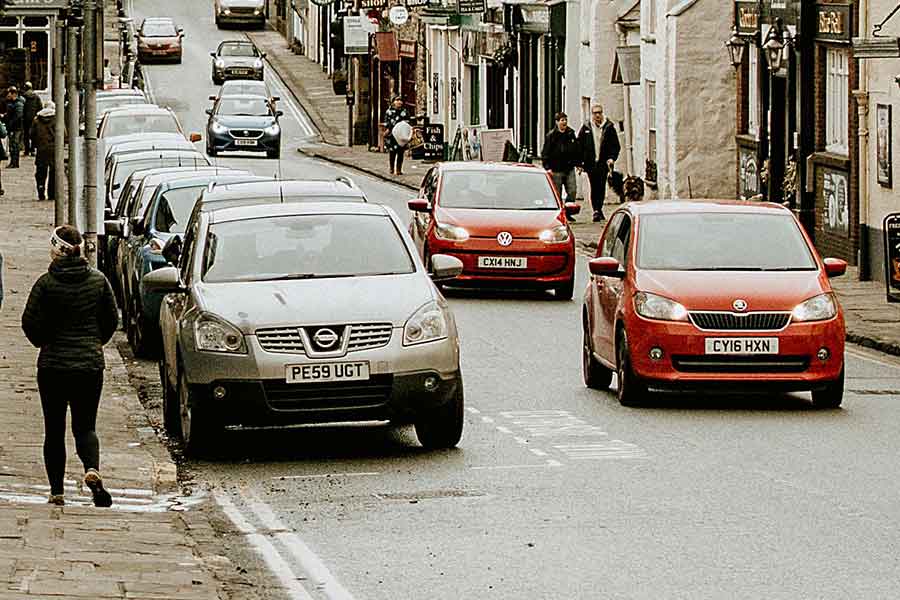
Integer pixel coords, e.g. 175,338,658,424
440,170,559,210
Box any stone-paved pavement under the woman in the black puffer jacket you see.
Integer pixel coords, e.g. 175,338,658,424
0,158,249,600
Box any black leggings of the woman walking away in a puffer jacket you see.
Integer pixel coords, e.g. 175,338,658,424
38,369,103,494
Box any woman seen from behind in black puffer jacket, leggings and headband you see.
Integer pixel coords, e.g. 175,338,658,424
22,225,119,506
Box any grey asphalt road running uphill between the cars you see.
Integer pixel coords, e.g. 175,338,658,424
133,0,900,600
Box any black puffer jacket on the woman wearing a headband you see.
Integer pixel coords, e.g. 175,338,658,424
22,257,119,371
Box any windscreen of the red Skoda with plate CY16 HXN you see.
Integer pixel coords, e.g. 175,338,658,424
637,212,818,271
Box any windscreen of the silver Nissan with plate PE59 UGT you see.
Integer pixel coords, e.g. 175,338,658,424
203,214,415,283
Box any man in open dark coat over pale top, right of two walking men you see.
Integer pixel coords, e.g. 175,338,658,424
578,104,621,223
